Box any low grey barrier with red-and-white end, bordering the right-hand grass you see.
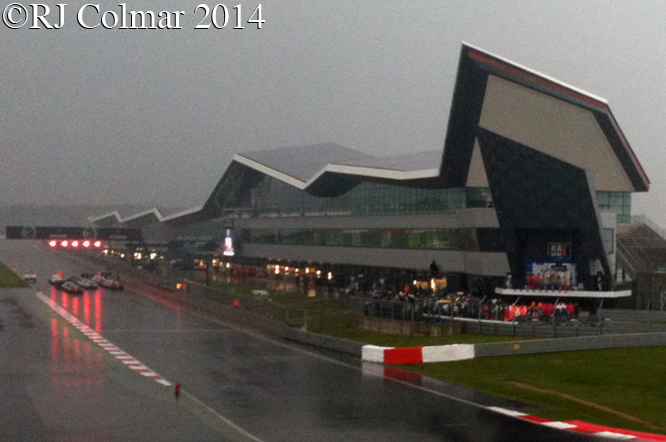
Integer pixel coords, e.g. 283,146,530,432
361,333,666,364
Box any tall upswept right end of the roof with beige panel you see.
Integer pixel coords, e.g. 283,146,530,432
441,44,650,192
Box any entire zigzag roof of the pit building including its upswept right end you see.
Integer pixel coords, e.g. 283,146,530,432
90,43,649,226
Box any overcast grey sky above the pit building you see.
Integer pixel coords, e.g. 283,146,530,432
0,0,666,225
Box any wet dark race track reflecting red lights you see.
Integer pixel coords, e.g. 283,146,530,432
0,241,597,442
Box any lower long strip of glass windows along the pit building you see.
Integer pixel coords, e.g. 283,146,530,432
242,229,504,251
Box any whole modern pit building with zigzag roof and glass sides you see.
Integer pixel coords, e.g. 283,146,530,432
90,44,649,306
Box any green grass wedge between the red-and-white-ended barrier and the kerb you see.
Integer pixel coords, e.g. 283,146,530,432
402,347,666,433
